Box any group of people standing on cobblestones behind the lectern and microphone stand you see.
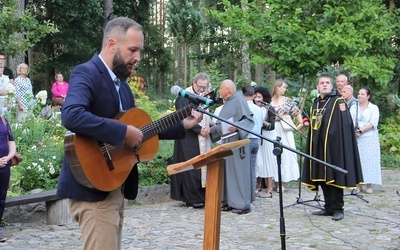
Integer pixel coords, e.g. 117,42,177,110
171,73,382,223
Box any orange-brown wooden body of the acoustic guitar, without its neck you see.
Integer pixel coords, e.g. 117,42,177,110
64,108,159,191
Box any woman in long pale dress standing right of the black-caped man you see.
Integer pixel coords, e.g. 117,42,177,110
350,88,382,194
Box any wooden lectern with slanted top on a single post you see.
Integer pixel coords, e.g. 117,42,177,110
167,139,250,250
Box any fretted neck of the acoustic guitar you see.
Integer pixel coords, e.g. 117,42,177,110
140,104,193,141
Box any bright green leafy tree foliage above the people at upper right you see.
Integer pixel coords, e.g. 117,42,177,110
212,0,399,84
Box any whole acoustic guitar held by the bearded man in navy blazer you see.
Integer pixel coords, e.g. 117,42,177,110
64,104,194,191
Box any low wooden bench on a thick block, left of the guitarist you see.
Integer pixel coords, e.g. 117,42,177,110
5,189,73,225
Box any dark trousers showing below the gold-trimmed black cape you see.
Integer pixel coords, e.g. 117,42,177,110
320,183,344,213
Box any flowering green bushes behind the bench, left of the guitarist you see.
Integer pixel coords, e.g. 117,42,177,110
8,116,66,193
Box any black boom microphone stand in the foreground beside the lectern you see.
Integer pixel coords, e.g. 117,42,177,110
196,106,348,250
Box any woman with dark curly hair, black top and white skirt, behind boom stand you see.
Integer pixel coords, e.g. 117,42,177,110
254,87,278,198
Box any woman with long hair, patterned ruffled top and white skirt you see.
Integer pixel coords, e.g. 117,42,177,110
271,79,303,192
